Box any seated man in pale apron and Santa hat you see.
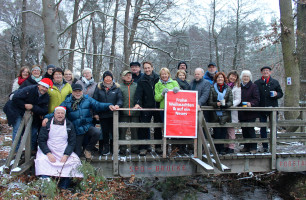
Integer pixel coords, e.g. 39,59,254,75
35,106,83,189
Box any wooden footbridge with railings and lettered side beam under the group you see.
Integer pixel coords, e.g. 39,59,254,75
2,107,306,177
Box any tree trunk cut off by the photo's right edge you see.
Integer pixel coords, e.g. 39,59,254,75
297,1,306,104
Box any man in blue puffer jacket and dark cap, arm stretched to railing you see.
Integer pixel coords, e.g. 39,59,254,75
43,84,116,159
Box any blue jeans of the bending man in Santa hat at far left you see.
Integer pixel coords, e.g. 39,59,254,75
13,116,39,151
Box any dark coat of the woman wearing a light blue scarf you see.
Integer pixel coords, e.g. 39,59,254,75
208,84,233,124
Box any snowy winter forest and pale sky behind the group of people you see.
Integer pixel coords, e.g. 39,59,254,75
0,0,306,118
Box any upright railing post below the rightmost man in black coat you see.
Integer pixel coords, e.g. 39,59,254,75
269,110,277,169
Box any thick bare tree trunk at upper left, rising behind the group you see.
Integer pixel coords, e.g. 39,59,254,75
42,0,59,66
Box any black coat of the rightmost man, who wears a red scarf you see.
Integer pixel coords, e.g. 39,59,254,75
254,77,283,107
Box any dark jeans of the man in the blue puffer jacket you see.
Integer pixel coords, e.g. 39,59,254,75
74,126,100,157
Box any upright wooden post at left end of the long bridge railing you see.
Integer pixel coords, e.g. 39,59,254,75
113,110,119,176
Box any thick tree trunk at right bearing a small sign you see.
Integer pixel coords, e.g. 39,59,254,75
279,0,300,119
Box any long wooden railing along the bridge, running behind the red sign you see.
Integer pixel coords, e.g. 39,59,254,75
113,106,306,175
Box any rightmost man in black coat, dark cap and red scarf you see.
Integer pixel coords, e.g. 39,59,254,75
254,66,283,152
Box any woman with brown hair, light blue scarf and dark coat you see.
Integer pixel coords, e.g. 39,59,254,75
208,72,233,155
